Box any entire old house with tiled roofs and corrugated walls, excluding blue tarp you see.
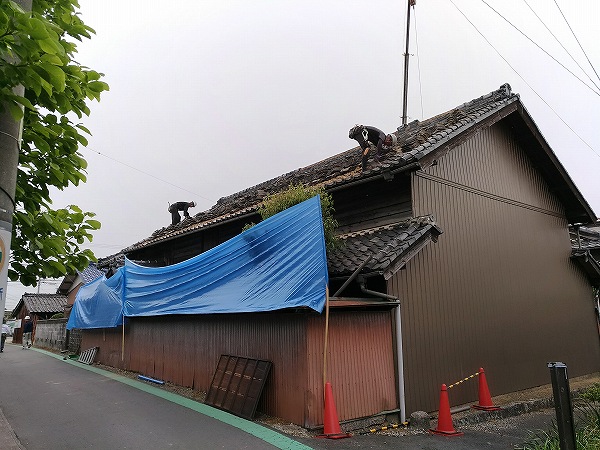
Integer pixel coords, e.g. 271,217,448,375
82,85,600,427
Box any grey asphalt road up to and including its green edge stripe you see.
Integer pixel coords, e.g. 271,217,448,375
0,344,307,450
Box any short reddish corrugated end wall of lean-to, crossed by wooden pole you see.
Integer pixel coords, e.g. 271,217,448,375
304,309,398,428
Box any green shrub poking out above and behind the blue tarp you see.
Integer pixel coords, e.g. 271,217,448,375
244,183,340,250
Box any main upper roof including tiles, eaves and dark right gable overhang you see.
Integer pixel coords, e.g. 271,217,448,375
122,84,595,254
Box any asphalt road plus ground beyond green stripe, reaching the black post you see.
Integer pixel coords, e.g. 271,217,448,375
0,343,555,450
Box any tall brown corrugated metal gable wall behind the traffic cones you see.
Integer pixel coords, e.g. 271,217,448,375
390,124,600,411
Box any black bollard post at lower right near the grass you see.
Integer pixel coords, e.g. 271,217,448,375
548,362,577,450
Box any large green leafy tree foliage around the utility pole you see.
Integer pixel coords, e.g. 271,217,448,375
0,0,108,285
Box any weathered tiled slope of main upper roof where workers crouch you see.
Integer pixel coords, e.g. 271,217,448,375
123,84,519,254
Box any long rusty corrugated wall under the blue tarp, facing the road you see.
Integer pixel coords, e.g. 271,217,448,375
81,314,306,424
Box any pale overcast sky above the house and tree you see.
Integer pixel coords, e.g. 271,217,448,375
6,0,600,309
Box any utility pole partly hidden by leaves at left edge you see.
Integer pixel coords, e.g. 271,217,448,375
0,0,32,317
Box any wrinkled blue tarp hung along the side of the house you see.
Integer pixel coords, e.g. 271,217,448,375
67,196,328,329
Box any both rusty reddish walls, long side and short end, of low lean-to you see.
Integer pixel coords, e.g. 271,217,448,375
81,311,396,427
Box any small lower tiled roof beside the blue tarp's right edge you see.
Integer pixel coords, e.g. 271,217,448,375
328,216,442,279
